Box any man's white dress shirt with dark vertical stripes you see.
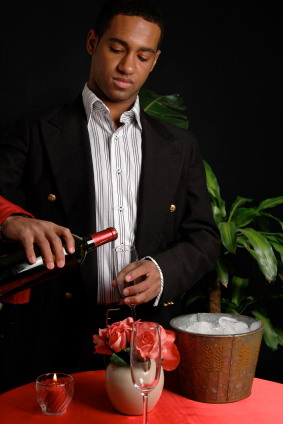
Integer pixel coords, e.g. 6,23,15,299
82,85,142,304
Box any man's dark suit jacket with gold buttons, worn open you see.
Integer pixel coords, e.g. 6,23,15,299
0,96,219,390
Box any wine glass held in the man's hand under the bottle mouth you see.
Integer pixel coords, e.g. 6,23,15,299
114,244,138,321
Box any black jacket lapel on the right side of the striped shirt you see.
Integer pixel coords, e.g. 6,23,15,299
136,111,184,257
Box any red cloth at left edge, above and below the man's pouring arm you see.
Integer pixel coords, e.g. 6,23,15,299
0,196,33,304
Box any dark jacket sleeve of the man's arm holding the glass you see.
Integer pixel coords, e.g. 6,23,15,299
151,134,220,302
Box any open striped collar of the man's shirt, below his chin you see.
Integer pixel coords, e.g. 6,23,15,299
82,84,142,129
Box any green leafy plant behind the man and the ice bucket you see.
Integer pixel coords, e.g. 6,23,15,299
140,89,283,350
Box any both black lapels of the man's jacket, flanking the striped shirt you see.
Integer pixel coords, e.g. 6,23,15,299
42,97,184,272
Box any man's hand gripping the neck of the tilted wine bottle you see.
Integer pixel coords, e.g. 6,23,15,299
2,215,75,269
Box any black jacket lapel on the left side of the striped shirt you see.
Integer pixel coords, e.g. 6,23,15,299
42,96,95,235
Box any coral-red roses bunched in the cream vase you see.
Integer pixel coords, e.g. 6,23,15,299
93,317,180,371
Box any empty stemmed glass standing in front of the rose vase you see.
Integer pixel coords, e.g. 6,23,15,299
130,321,161,424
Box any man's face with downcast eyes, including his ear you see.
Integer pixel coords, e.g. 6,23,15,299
87,15,160,106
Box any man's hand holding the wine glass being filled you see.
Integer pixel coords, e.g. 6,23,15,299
112,260,161,305
